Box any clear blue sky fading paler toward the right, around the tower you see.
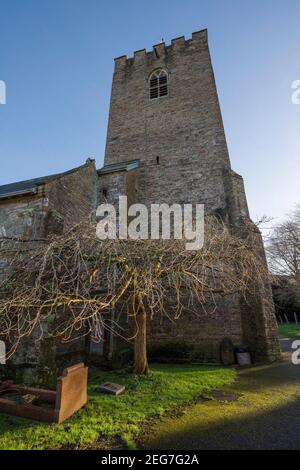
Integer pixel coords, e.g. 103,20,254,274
0,0,300,219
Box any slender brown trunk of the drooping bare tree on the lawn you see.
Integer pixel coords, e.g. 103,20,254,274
133,300,149,375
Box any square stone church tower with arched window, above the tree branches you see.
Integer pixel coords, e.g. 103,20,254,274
105,30,249,224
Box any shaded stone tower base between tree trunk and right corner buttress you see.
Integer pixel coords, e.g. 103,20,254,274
148,296,244,363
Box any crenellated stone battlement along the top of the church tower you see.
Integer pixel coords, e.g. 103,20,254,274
115,29,208,70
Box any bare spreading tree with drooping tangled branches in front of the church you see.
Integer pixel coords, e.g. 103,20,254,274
0,217,268,374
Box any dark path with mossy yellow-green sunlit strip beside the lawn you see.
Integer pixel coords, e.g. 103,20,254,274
142,361,300,450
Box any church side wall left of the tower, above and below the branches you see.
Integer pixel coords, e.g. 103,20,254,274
0,161,98,386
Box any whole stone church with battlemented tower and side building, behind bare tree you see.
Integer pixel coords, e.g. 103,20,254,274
0,30,279,382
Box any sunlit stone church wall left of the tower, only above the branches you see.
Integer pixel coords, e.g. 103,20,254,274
0,161,98,240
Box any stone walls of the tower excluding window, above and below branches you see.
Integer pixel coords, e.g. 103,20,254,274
100,30,279,361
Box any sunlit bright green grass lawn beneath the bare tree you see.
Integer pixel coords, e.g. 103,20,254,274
0,364,235,450
